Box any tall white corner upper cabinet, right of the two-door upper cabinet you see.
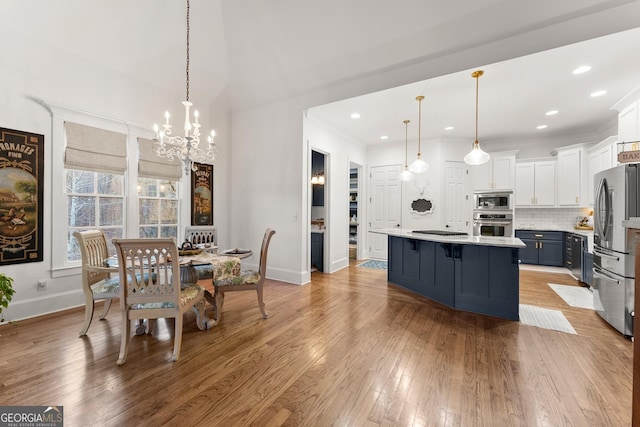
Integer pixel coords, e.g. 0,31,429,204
557,147,587,207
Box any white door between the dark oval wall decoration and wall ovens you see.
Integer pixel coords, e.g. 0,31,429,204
444,162,472,233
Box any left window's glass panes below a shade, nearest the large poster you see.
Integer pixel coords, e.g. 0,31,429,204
65,169,125,261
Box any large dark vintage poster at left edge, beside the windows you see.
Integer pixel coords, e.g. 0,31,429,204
0,128,44,265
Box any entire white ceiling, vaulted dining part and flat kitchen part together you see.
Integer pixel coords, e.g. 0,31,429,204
0,0,640,135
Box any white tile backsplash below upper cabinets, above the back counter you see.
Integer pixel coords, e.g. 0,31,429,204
513,208,593,230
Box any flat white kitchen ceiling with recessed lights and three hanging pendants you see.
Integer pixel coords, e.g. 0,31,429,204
308,28,640,146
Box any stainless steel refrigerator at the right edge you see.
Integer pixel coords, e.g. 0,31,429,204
593,164,640,336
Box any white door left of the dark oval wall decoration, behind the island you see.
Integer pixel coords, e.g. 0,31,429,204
368,165,402,259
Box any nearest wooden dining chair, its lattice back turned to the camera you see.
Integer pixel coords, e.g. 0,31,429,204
113,239,209,365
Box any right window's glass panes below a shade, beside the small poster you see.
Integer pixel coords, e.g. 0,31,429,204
138,178,178,239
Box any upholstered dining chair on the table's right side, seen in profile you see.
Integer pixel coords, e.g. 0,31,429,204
213,228,276,323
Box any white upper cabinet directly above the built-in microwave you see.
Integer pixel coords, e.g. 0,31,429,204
471,151,517,190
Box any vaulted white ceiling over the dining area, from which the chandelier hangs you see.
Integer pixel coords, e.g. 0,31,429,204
2,0,640,145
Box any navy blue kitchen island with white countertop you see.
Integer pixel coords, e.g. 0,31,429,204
372,229,525,320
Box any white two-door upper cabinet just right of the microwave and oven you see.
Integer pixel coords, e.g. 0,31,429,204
514,161,556,207
